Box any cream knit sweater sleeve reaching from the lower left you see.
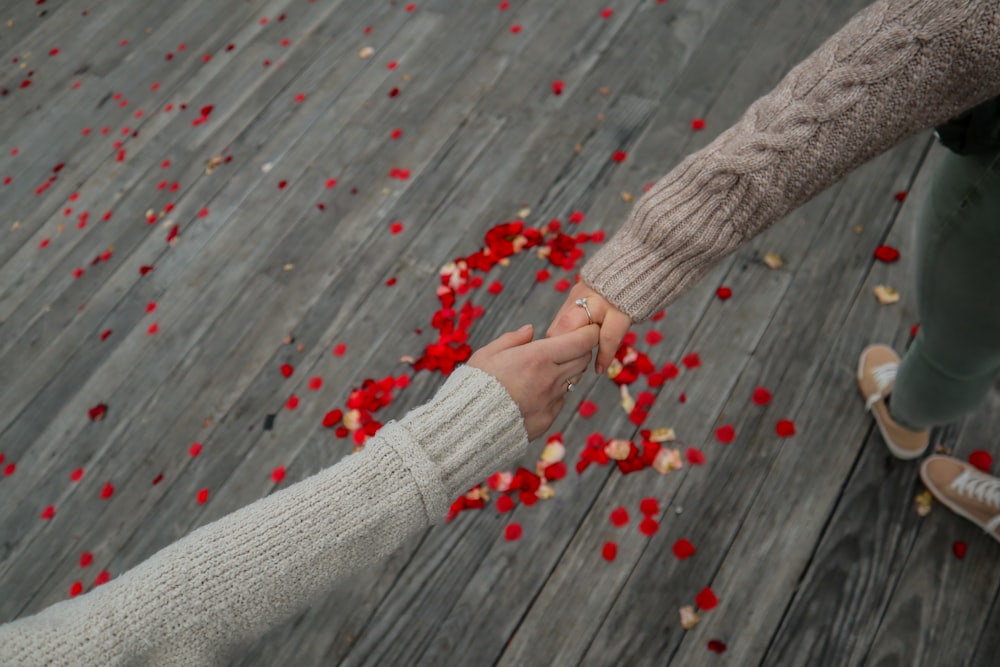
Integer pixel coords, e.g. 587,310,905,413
0,366,527,667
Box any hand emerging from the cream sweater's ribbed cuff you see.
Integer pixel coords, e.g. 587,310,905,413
468,324,598,440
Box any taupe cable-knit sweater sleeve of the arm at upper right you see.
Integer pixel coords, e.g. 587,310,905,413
582,0,1000,321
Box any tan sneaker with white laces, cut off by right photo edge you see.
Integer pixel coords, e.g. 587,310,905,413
920,456,1000,542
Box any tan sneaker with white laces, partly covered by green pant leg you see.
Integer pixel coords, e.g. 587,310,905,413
858,345,930,460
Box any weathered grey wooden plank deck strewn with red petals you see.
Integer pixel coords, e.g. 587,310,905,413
0,0,1000,666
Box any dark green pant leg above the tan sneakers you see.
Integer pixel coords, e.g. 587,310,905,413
890,152,1000,428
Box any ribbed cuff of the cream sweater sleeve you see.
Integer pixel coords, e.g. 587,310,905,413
398,366,528,521
